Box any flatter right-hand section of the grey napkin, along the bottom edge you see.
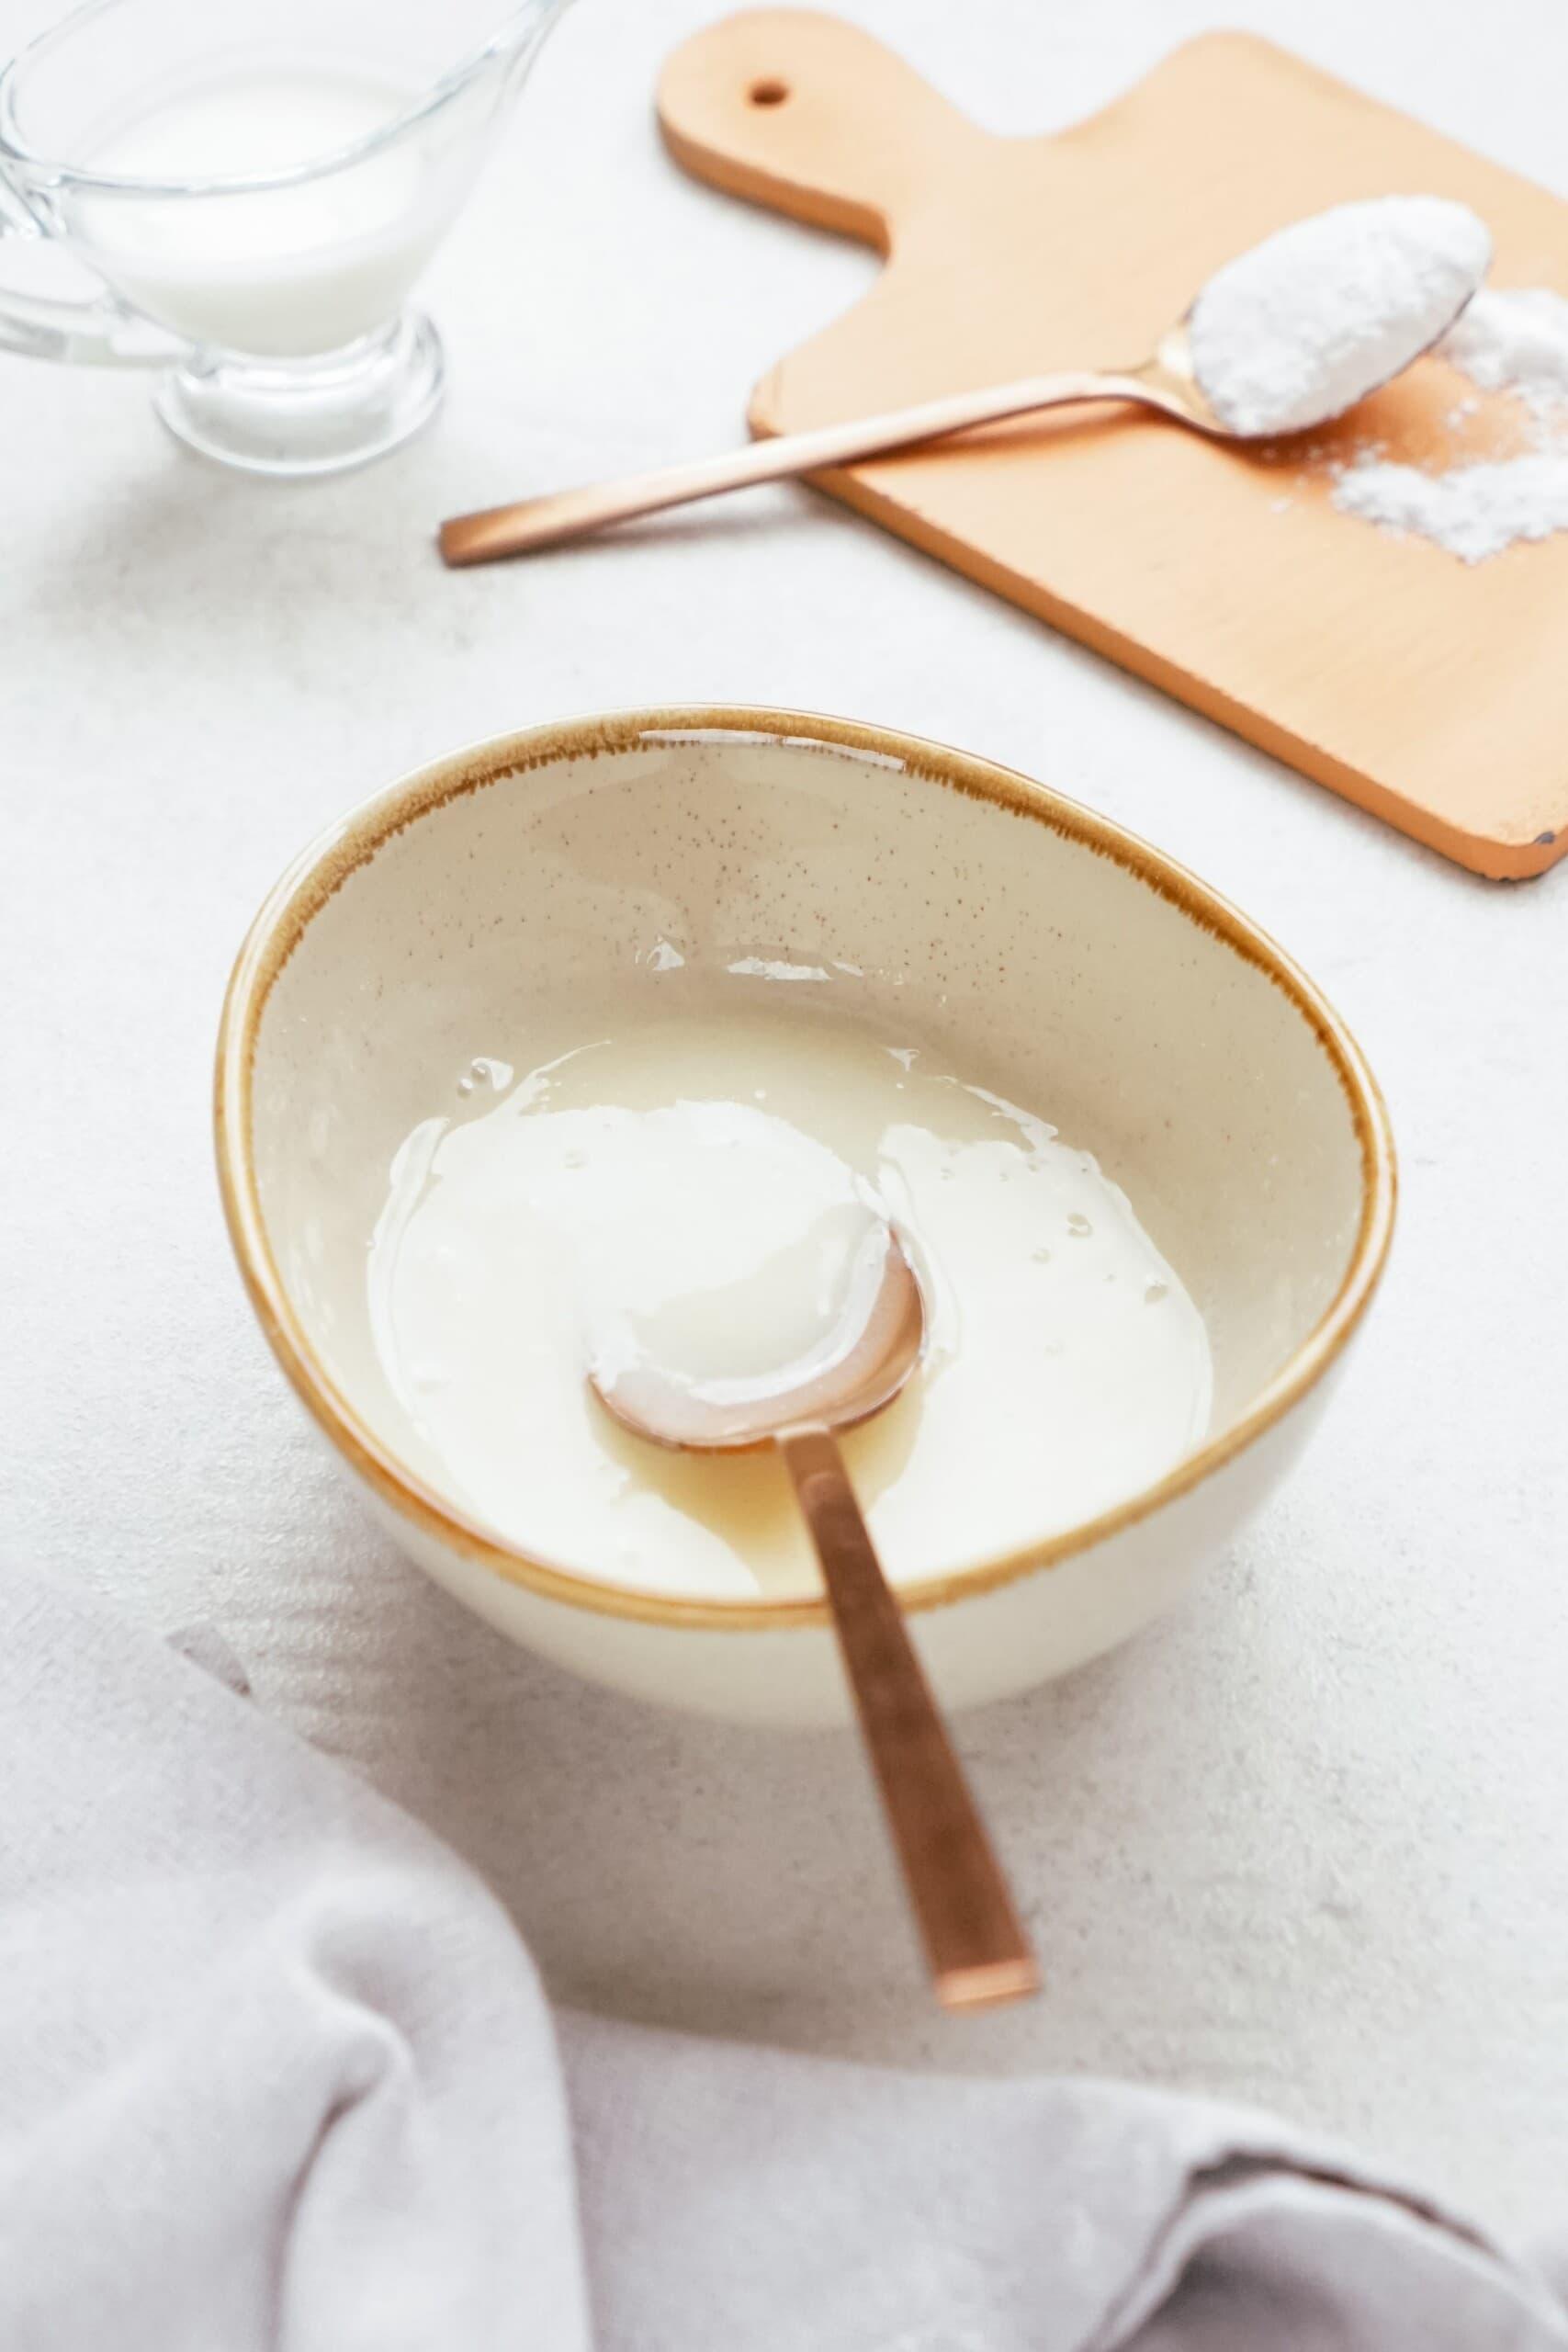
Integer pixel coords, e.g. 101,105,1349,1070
562,2013,1568,2352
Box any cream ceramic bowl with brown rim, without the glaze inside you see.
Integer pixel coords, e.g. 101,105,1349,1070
216,708,1394,1722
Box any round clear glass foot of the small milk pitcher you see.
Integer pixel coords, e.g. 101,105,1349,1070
152,312,445,473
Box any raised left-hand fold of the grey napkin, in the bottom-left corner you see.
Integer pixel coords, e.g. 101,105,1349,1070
0,1566,588,2352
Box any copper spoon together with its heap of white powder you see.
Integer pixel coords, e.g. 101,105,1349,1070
440,195,1493,564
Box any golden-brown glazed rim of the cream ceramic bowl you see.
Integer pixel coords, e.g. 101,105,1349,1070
214,706,1396,1633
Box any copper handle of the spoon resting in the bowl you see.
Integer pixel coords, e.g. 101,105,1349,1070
778,1428,1039,2008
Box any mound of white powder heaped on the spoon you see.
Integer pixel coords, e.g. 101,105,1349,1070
1190,195,1493,435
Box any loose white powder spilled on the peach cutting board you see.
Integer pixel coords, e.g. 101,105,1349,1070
1333,287,1568,564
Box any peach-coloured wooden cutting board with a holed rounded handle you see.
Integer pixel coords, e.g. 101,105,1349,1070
659,9,1568,875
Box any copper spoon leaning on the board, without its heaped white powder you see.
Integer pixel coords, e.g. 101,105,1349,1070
440,198,1488,564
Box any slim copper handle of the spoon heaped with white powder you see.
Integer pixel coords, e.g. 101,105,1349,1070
437,371,1128,567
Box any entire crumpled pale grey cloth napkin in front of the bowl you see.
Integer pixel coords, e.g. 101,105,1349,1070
0,1569,1568,2352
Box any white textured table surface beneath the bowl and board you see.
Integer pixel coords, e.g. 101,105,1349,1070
0,0,1568,2227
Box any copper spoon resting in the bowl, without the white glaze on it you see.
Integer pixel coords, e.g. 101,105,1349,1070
590,1230,1039,2008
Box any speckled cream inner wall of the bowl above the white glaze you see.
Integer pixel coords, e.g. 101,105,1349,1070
221,710,1392,1611
